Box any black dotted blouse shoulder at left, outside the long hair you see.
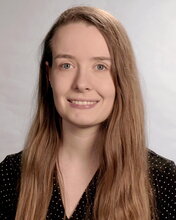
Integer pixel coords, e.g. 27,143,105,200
0,152,22,219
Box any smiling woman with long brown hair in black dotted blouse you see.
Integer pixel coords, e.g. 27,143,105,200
0,7,176,220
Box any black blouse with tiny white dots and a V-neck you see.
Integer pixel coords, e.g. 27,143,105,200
0,150,176,220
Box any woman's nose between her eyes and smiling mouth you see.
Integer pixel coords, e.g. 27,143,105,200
73,67,92,92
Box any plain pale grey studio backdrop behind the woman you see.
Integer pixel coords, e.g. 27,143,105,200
0,0,176,162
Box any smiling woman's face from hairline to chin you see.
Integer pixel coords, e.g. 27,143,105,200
49,22,115,127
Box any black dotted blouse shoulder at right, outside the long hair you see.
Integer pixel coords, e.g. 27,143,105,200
148,150,176,219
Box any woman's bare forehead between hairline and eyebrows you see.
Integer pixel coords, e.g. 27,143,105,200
52,22,110,56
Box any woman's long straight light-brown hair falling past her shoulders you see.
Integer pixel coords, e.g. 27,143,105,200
16,6,154,220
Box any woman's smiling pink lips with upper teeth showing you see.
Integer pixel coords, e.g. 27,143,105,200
68,99,99,109
